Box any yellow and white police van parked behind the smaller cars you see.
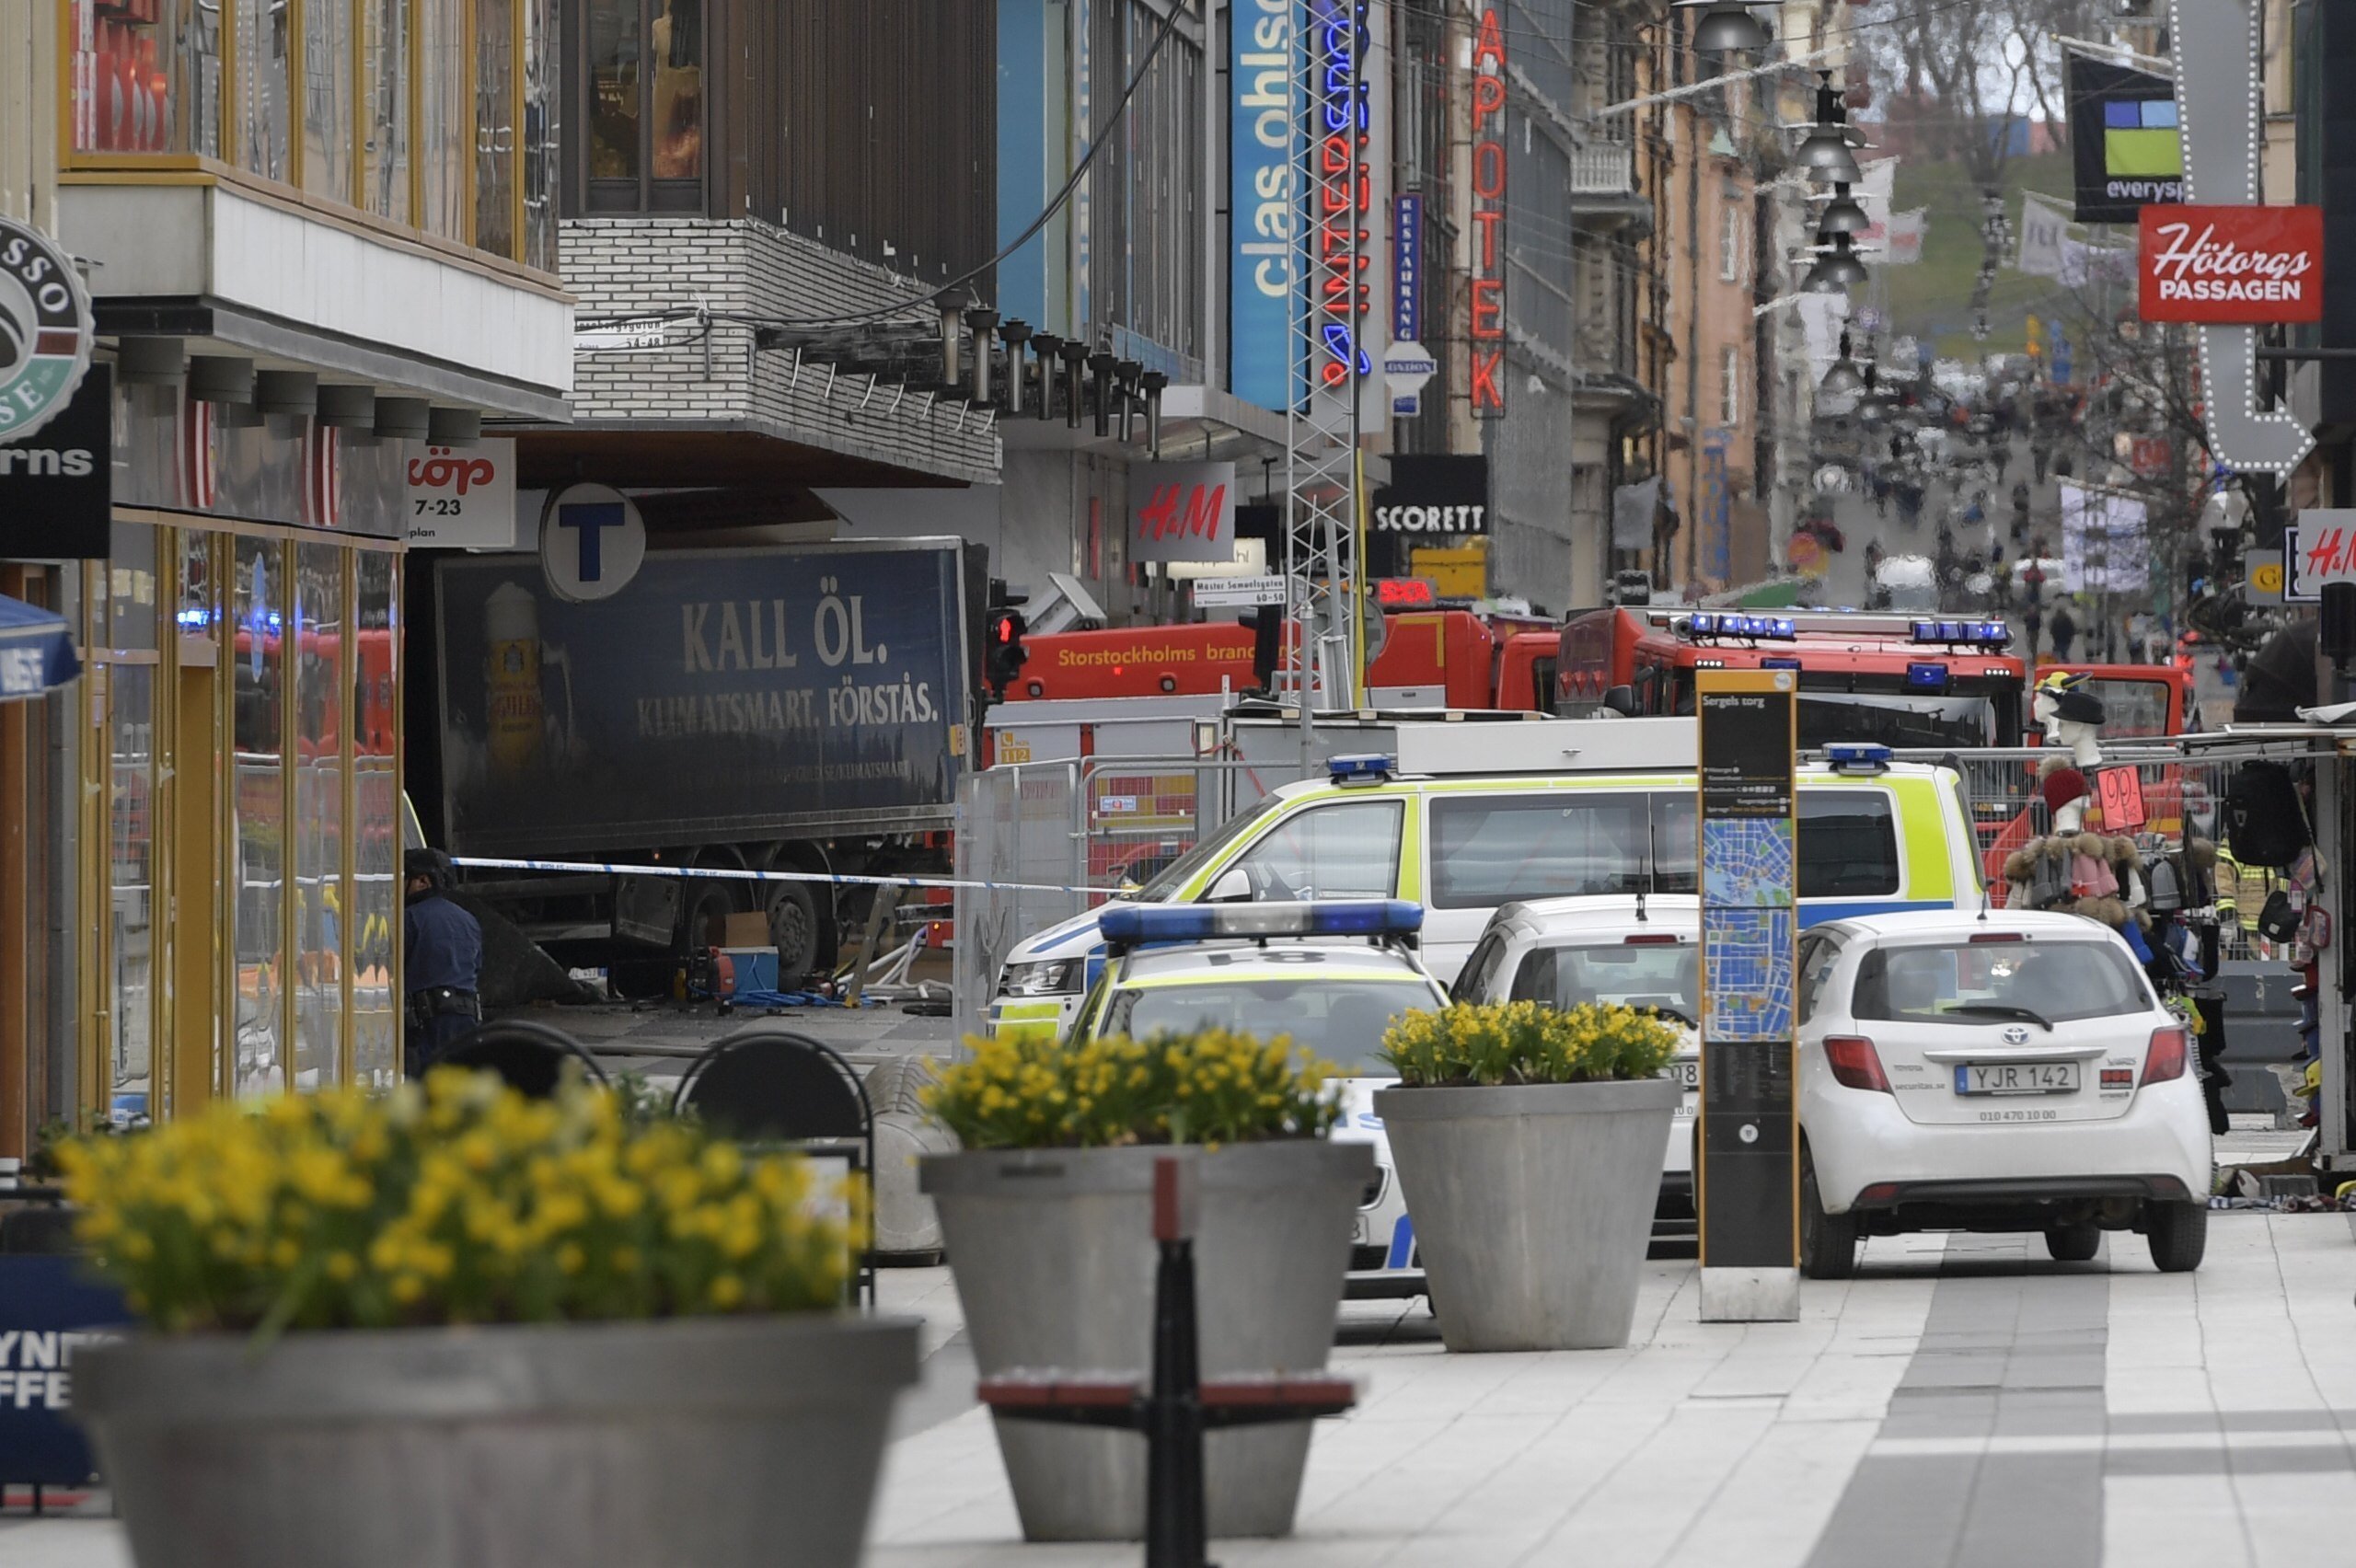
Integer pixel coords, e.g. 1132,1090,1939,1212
989,718,1981,1033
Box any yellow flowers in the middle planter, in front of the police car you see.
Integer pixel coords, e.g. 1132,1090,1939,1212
926,1029,1336,1149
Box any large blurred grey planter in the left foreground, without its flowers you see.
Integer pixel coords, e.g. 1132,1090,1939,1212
73,1314,917,1568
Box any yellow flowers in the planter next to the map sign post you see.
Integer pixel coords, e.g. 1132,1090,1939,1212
1383,1000,1678,1088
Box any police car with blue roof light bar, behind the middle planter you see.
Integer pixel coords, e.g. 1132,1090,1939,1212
1079,899,1449,1295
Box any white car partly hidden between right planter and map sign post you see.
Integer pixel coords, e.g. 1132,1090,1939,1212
1449,893,1701,1231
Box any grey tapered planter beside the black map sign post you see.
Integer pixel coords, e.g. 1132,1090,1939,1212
1373,1078,1680,1352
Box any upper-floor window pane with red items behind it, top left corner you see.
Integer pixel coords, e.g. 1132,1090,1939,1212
73,0,222,156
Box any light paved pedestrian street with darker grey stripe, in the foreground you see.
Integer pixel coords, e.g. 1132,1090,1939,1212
870,1213,2356,1568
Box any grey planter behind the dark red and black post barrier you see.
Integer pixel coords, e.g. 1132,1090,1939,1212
921,1139,1373,1539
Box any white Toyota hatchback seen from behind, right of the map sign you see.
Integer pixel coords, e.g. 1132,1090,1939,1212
1796,909,2210,1278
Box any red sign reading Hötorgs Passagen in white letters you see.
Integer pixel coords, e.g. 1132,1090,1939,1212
2137,207,2323,328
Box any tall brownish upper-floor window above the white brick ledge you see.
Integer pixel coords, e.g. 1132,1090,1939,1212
582,0,704,212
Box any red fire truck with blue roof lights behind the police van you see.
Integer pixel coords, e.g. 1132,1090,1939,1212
1555,605,2028,746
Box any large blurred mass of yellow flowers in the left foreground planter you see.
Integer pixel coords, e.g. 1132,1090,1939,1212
59,1069,865,1335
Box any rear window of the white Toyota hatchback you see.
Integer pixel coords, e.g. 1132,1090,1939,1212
1850,937,2155,1029
